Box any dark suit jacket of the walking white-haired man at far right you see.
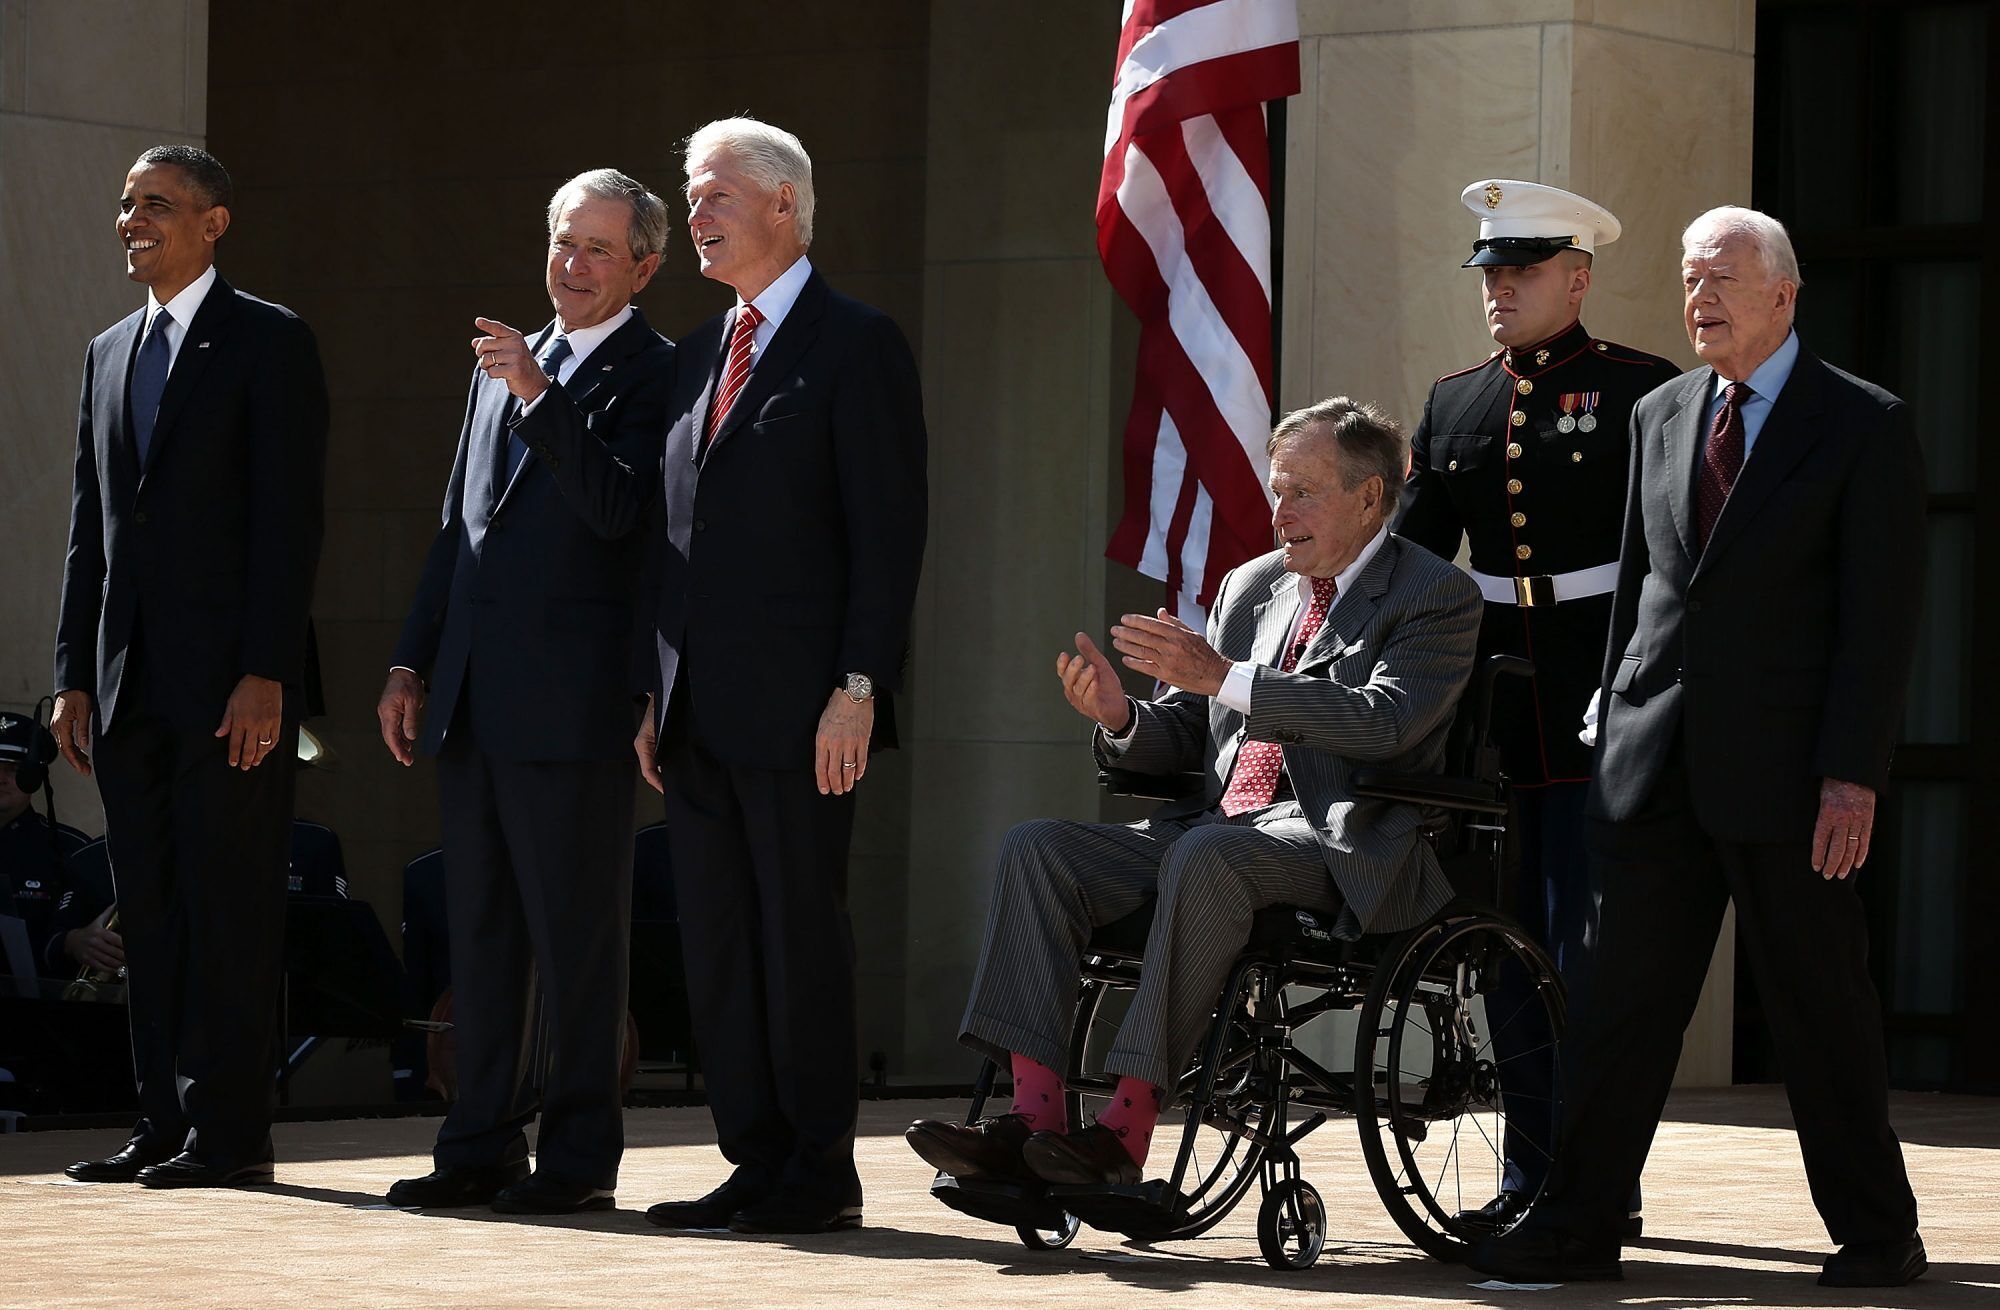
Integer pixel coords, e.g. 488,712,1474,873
1590,350,1926,844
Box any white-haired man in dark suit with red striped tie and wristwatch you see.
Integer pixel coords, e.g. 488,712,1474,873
522,118,926,1232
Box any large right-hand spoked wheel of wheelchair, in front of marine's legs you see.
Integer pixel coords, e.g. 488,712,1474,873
1354,914,1564,1262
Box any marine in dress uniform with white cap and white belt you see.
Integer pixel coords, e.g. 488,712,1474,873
1396,178,1680,1226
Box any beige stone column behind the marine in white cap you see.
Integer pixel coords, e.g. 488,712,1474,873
1280,0,1756,1084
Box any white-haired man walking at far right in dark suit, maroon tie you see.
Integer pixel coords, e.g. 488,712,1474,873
1470,208,1926,1286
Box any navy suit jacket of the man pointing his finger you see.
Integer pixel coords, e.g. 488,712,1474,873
392,308,674,760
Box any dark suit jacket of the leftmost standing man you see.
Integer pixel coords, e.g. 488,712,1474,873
56,276,326,732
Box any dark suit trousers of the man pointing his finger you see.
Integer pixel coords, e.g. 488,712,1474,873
434,728,634,1188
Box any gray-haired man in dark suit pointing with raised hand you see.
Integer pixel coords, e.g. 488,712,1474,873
376,168,674,1214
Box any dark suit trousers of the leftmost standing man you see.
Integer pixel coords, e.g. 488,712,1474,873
94,688,298,1166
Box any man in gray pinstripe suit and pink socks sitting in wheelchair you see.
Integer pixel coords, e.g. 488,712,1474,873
906,396,1480,1184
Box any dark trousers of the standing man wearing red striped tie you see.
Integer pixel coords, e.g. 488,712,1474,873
660,688,862,1204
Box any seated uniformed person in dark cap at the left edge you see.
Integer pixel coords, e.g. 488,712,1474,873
0,714,99,978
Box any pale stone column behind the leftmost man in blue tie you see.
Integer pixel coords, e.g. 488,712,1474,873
0,0,208,832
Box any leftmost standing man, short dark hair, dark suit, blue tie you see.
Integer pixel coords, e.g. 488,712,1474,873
50,146,326,1188
